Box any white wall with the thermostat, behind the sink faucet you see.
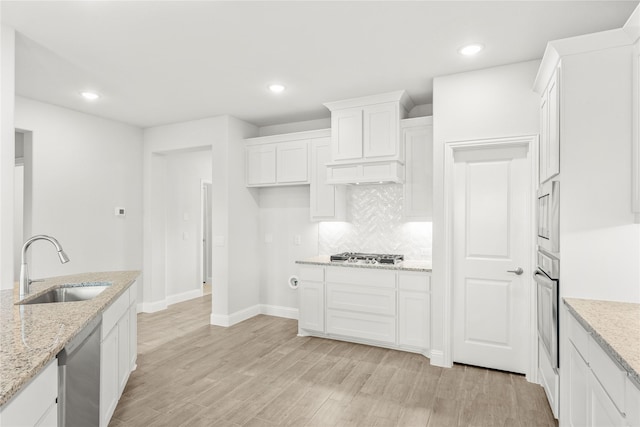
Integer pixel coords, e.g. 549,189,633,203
12,97,142,278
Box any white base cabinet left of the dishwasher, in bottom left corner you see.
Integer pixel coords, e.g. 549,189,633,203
0,358,58,427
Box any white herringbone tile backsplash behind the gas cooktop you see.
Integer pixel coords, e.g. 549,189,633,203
318,184,431,260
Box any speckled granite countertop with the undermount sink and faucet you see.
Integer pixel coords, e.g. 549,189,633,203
0,271,140,405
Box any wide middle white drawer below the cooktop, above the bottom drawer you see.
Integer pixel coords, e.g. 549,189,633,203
327,283,396,316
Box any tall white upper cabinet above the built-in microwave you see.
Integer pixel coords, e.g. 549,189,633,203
539,68,560,183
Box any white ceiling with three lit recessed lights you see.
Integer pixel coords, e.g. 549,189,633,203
0,0,638,127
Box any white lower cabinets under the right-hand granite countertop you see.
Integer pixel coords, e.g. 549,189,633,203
566,314,640,427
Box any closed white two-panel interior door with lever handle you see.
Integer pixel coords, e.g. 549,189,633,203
452,145,532,373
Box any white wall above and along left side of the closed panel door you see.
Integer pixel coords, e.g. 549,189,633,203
431,61,539,366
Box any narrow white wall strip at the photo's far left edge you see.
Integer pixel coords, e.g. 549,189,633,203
0,25,15,289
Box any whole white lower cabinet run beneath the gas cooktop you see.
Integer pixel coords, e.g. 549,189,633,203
298,265,431,355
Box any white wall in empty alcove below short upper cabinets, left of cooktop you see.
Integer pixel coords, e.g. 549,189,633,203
259,185,319,309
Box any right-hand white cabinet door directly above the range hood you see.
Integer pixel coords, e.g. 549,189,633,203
362,102,399,159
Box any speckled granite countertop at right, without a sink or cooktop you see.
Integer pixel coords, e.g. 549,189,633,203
564,298,640,385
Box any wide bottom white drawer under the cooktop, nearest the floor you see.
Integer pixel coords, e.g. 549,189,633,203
327,309,396,344
